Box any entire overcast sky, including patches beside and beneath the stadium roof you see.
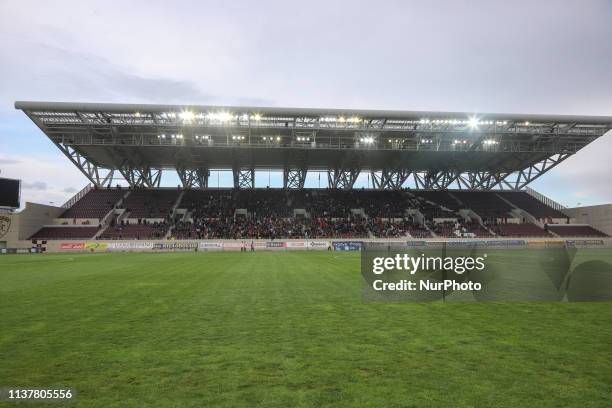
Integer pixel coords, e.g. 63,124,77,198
0,0,612,206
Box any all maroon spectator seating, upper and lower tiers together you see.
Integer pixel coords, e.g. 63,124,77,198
28,188,605,239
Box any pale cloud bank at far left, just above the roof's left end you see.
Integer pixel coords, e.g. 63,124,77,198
0,38,214,106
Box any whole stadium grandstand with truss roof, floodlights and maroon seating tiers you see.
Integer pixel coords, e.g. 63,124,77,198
15,102,612,240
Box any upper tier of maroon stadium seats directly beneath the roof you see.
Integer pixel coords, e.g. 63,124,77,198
56,188,566,222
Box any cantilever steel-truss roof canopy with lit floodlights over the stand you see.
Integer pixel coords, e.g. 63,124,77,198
15,102,612,189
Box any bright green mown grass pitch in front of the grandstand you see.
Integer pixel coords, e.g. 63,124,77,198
0,252,612,408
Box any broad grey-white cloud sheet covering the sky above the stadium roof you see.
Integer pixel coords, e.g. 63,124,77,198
0,0,612,114
